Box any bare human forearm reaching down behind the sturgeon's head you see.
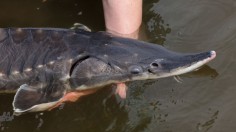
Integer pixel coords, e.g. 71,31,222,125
103,0,142,39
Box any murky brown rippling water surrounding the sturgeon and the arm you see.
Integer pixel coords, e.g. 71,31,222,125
0,0,236,132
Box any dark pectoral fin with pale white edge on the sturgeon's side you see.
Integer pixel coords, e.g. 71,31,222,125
12,82,66,114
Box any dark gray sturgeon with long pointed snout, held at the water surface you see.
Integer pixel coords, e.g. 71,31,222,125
0,28,216,113
